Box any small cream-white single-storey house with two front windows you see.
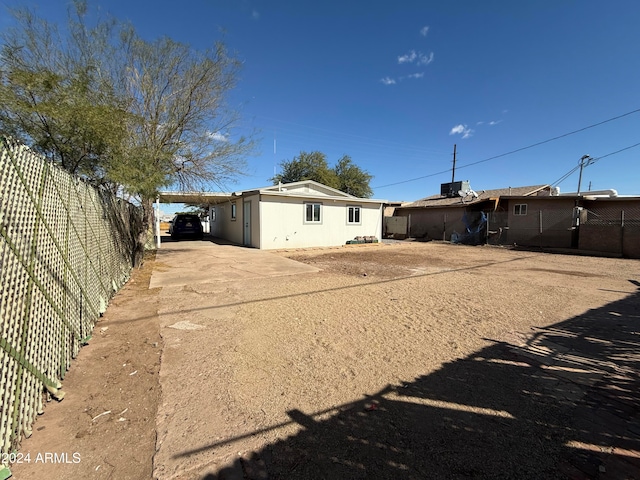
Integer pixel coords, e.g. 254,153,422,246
209,180,385,249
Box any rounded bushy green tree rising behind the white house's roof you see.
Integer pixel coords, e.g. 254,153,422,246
270,152,373,198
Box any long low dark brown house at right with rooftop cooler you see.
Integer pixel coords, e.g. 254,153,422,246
394,184,640,258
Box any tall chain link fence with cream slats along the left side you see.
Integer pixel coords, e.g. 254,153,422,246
0,138,142,462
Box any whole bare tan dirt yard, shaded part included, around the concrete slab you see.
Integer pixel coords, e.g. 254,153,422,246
12,242,640,480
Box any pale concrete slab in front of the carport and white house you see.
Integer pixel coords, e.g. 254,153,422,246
149,240,319,288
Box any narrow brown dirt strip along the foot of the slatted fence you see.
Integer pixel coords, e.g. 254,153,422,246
11,251,162,480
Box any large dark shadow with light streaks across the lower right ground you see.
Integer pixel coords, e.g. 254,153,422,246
194,284,640,480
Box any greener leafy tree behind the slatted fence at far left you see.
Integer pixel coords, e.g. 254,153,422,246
0,4,129,183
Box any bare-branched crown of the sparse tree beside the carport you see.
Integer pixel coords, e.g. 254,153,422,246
114,32,253,195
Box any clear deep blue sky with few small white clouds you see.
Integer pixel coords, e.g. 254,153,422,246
0,0,640,214
